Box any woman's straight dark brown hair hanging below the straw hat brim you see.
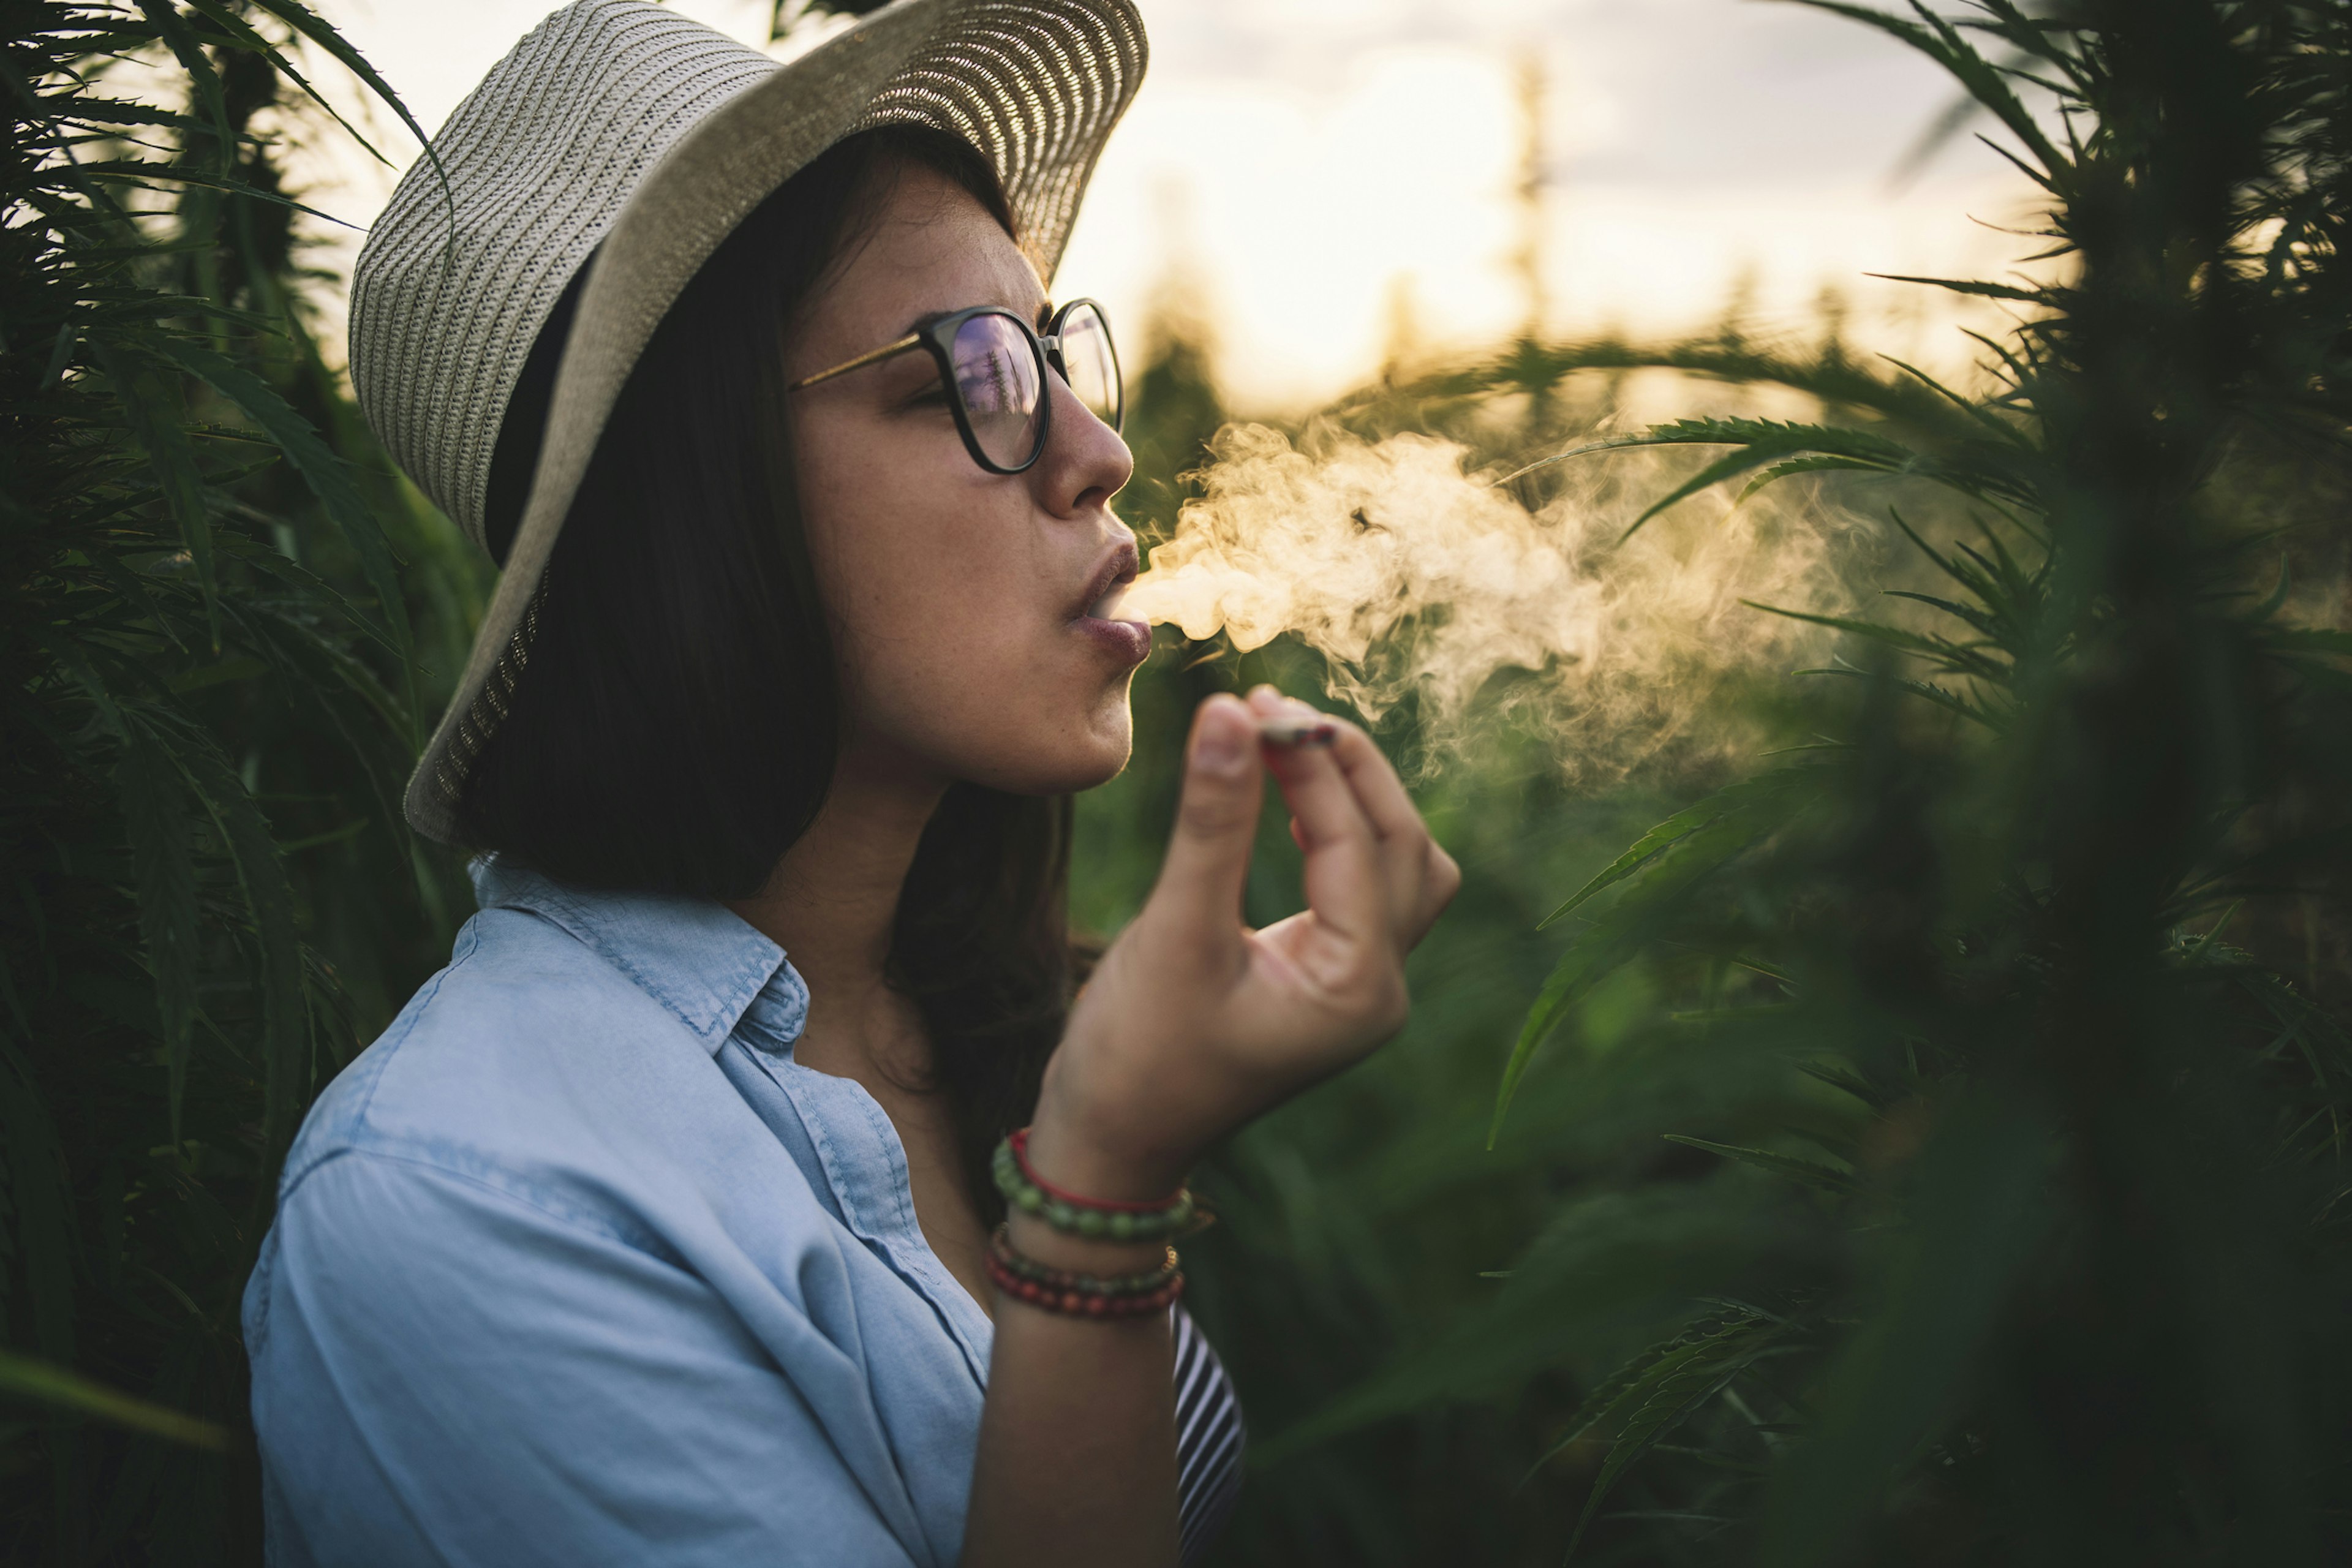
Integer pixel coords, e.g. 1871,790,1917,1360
459,127,1072,1206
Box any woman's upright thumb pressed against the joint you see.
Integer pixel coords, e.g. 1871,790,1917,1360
1153,693,1265,943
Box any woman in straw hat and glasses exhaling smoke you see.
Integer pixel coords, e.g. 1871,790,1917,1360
244,0,1456,1566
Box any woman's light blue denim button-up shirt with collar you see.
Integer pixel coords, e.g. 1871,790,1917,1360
244,863,1011,1568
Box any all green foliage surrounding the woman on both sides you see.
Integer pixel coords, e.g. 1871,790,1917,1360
0,0,2352,1566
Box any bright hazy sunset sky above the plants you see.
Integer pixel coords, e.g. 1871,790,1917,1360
313,0,2030,412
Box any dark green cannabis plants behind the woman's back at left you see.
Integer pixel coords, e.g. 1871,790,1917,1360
0,0,475,1563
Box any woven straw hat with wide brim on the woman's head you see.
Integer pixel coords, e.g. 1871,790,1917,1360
350,0,1145,844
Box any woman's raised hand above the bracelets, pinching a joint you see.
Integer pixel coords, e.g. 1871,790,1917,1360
1030,687,1461,1201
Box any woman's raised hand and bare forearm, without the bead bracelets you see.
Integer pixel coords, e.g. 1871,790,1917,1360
964,689,1461,1568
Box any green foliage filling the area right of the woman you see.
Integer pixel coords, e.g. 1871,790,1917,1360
1101,0,2352,1566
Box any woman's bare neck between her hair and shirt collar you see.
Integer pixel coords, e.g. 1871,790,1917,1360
729,745,948,1082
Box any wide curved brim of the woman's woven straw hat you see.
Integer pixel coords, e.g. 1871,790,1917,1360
402,0,1148,844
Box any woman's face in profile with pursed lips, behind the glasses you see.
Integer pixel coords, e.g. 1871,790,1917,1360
786,165,1150,794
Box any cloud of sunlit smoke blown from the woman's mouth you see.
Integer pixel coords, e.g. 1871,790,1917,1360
1125,426,1837,776
